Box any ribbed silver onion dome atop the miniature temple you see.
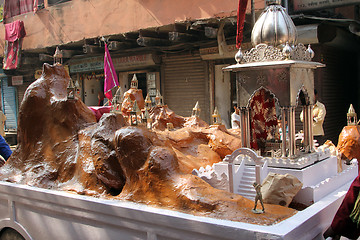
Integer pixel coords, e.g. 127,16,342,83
251,0,297,47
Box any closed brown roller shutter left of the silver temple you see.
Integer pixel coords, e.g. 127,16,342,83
162,53,210,123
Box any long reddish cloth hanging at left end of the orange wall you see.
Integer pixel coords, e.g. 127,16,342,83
3,20,26,70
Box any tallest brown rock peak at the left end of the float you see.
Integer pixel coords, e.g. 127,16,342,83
0,64,96,187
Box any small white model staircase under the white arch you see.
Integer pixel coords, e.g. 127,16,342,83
236,165,256,200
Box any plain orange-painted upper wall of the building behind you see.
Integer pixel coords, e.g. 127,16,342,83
0,0,264,54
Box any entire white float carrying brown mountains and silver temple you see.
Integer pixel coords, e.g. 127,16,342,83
0,2,358,240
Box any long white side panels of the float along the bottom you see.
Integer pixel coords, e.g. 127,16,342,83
0,182,351,240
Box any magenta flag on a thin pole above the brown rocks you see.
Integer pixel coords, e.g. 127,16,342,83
104,44,119,101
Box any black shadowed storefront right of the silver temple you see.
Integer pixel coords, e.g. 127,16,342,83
315,45,359,144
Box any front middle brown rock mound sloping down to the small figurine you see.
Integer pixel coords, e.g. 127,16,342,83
115,127,295,225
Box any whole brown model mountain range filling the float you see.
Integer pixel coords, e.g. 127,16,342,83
0,64,295,224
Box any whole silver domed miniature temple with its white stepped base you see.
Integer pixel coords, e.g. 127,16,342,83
205,0,357,208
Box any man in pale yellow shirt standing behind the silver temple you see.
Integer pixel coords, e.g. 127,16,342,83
300,89,326,146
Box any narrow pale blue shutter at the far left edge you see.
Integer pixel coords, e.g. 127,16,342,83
1,77,17,131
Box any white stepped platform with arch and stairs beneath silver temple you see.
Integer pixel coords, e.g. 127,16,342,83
200,148,358,206
